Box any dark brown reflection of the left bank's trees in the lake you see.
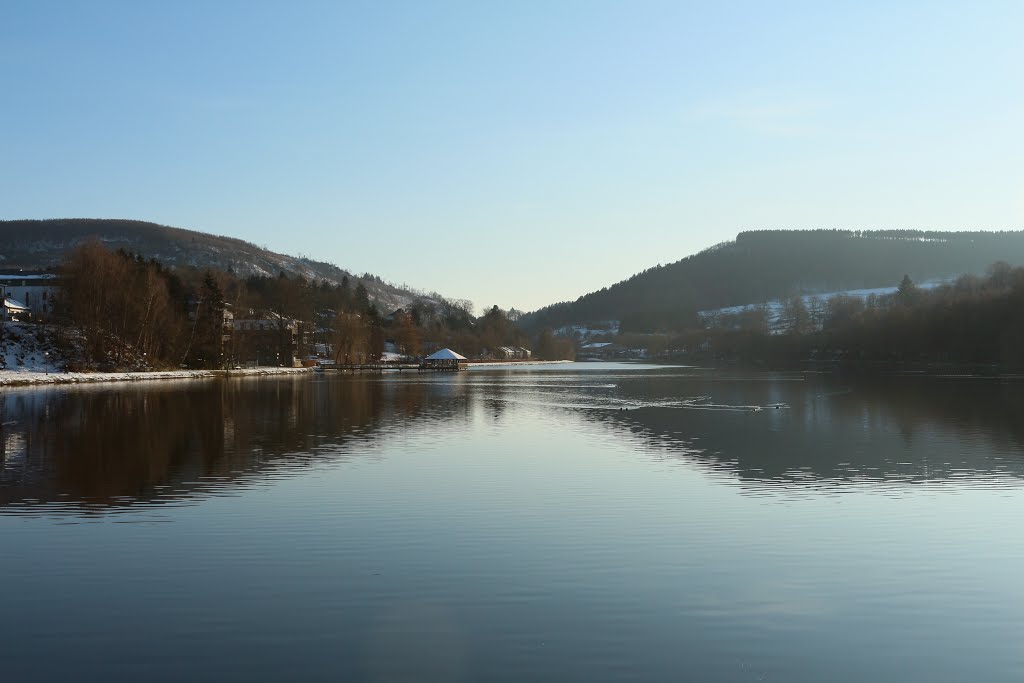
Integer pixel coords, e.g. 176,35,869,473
0,377,456,512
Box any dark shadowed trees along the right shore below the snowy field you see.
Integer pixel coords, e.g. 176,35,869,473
696,262,1024,368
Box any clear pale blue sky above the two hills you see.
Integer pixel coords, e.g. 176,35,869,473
0,0,1024,309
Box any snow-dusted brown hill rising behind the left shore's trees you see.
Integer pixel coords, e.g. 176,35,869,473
0,218,428,310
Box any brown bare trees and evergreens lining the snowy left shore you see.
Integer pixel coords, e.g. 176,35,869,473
53,241,529,369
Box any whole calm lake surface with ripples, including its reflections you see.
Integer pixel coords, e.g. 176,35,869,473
0,364,1024,683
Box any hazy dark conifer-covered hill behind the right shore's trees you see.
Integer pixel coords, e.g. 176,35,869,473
523,230,1024,332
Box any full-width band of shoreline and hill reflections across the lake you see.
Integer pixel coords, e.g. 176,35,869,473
0,369,1024,514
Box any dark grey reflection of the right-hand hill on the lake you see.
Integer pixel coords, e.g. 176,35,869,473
592,375,1024,489
